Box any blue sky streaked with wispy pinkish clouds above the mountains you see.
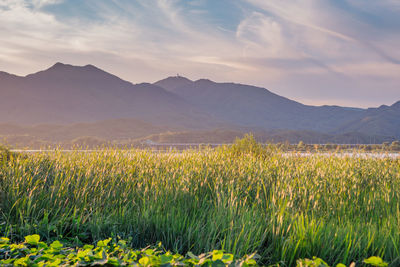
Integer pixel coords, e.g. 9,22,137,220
0,0,400,107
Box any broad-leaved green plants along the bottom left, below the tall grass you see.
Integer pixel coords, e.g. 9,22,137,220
0,235,258,266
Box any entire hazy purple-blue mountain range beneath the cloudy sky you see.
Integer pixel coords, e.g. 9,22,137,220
0,63,400,149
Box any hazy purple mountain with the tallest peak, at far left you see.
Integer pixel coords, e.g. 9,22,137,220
0,63,216,128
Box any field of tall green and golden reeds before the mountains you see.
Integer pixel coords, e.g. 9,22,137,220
0,138,400,266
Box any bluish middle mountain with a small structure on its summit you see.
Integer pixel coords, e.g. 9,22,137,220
155,77,364,132
